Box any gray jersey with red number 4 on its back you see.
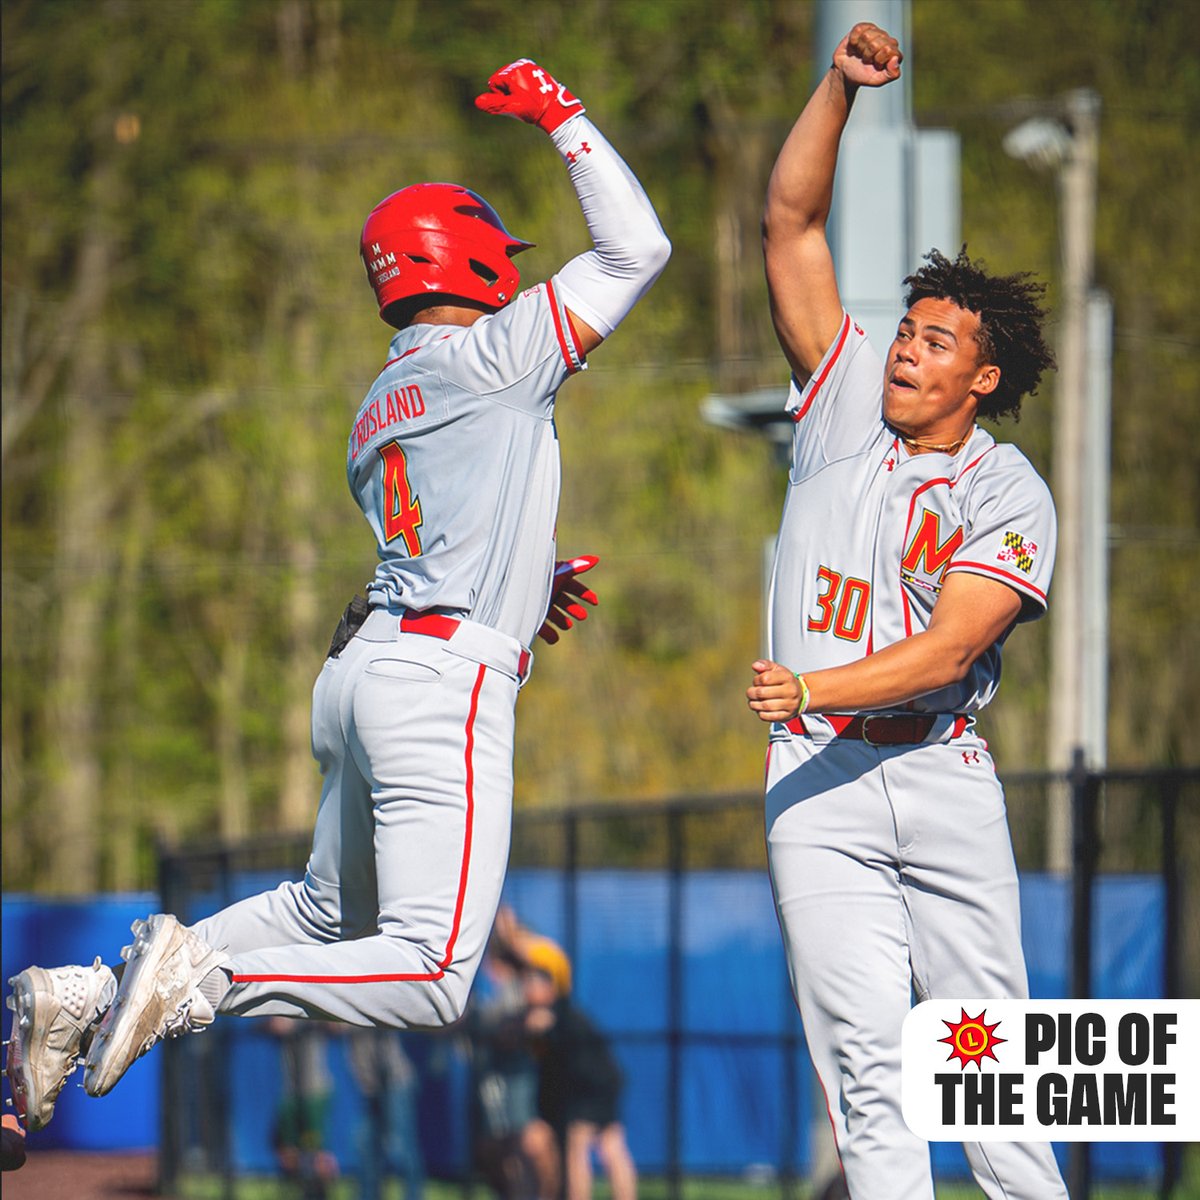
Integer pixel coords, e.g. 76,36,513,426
347,280,584,646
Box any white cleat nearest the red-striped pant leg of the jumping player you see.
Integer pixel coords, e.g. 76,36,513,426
83,913,227,1096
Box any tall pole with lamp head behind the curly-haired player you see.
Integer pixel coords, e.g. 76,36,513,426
1004,90,1108,872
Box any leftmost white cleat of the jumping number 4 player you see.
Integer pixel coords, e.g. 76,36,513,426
5,958,116,1133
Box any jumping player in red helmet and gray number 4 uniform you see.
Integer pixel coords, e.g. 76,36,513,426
10,59,671,1129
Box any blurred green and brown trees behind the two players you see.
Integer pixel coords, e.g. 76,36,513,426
2,0,1200,893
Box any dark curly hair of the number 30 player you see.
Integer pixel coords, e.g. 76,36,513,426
904,245,1055,420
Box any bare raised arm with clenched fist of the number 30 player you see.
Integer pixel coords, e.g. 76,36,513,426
762,23,904,384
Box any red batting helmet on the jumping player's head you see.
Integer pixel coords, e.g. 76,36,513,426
360,184,533,324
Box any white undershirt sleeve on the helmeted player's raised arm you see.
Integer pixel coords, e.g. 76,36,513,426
551,113,671,337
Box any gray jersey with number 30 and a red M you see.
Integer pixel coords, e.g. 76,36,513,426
769,316,1055,713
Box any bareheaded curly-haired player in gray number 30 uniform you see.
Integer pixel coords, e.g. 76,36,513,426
746,24,1066,1200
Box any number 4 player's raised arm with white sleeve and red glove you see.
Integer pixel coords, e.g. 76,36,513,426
475,59,671,354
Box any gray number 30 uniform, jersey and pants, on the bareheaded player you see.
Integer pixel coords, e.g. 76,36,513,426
766,316,1066,1200
